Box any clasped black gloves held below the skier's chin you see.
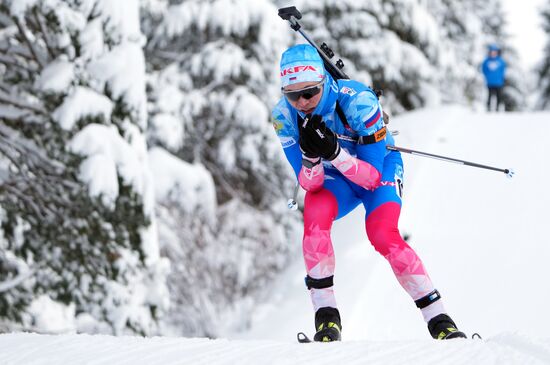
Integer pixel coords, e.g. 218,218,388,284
298,114,340,160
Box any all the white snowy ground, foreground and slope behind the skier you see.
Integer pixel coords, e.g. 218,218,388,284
0,107,550,365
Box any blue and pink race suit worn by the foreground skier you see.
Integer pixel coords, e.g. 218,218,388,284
272,75,445,321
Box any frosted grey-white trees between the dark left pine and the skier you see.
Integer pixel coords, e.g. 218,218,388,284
142,0,299,336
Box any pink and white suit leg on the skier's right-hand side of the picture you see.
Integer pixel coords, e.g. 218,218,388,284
365,202,445,321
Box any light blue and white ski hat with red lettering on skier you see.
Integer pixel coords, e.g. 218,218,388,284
280,44,325,87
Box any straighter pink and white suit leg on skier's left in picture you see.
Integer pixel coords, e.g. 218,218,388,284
302,189,338,311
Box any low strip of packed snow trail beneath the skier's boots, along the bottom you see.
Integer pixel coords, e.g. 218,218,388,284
0,334,550,365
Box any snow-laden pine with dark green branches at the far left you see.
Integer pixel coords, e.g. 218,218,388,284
0,0,167,334
